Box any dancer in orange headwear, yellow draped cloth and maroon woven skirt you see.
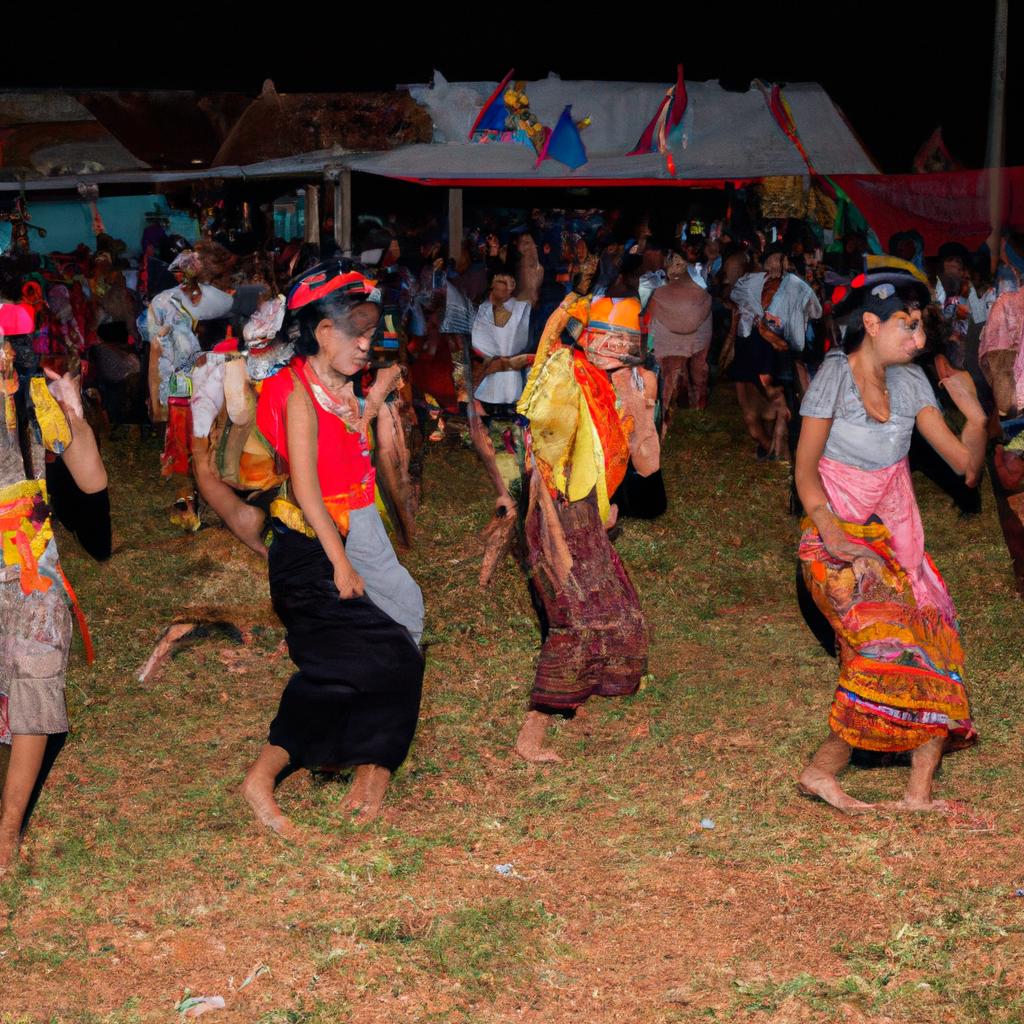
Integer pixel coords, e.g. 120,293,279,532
474,282,657,762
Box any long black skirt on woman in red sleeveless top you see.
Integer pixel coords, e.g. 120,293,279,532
268,521,424,771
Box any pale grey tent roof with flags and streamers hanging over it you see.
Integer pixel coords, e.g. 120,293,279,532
346,74,878,184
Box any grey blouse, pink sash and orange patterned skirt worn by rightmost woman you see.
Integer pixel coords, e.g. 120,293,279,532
800,350,977,752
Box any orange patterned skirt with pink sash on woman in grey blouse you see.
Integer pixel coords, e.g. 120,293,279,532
800,459,977,752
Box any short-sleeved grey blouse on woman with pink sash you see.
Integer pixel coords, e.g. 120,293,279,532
800,349,939,469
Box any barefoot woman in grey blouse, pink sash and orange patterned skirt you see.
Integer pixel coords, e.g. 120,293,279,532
796,271,985,813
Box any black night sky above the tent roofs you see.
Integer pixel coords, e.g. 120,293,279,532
8,0,1024,173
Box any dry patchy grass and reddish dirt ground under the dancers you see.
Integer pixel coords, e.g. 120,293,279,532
0,393,1024,1024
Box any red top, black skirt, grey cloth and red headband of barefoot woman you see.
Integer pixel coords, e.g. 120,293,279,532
256,273,424,771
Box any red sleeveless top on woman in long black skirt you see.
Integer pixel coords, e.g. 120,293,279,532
256,356,376,535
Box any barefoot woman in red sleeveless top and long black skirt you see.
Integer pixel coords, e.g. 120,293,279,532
242,263,424,838
